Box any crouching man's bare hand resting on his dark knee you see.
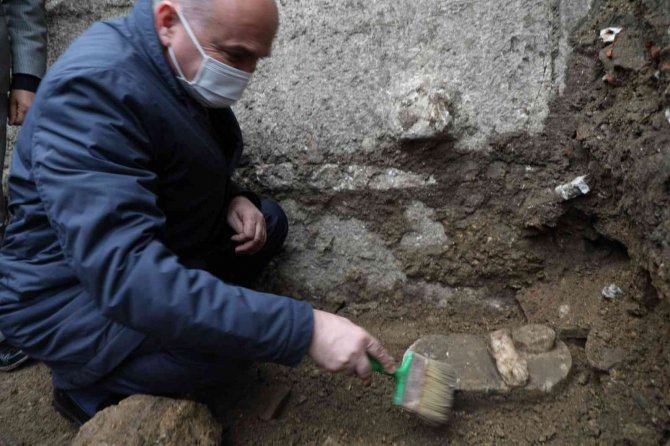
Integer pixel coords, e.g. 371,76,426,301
228,196,267,254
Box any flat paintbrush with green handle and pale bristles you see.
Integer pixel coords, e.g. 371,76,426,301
369,351,456,424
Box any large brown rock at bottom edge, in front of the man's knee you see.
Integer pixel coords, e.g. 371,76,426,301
72,395,222,446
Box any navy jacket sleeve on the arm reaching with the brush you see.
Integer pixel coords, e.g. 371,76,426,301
31,71,313,365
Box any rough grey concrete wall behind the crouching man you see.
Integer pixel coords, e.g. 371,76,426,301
10,0,591,303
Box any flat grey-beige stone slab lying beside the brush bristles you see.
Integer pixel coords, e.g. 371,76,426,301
409,327,572,395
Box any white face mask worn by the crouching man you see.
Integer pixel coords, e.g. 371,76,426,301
168,10,251,108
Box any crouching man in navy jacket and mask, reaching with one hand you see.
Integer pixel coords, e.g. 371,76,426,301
0,0,395,423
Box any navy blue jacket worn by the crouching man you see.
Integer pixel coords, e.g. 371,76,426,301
0,0,313,388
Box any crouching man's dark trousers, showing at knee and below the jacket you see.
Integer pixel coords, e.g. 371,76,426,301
63,200,288,416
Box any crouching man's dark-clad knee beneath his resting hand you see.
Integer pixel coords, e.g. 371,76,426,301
208,199,288,286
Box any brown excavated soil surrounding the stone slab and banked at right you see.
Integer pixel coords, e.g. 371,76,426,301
0,0,670,446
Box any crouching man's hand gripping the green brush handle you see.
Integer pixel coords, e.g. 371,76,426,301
309,310,396,385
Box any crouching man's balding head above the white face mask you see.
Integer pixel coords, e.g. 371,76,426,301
154,0,279,78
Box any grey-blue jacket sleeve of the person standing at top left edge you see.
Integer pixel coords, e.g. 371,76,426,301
3,0,47,78
